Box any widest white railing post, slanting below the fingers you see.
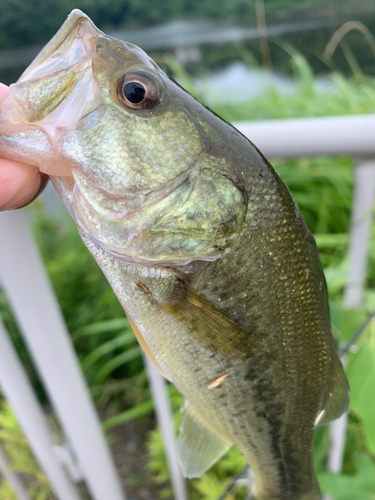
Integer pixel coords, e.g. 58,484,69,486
0,211,125,500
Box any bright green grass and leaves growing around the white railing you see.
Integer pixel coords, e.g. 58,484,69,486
0,48,375,500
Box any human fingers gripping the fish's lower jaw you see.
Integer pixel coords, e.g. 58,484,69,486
0,83,48,210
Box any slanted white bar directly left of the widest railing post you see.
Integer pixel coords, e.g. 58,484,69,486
0,319,80,500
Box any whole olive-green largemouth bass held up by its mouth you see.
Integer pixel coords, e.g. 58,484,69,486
0,10,348,500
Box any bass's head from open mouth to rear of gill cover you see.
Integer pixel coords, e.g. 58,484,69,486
0,10,247,266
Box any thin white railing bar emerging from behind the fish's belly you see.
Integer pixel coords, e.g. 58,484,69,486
144,356,189,500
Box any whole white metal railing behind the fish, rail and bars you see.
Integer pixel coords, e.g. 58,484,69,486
0,115,375,500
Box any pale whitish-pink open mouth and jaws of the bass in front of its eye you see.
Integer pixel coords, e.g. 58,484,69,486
0,9,103,176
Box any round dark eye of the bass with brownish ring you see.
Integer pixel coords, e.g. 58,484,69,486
117,73,159,109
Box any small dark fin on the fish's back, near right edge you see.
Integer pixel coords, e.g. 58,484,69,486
315,353,349,425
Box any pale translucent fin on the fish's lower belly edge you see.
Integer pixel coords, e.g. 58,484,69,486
177,401,231,477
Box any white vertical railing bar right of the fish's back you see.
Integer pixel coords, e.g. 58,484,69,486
327,158,375,474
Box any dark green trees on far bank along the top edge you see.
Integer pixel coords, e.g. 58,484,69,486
0,0,364,48
